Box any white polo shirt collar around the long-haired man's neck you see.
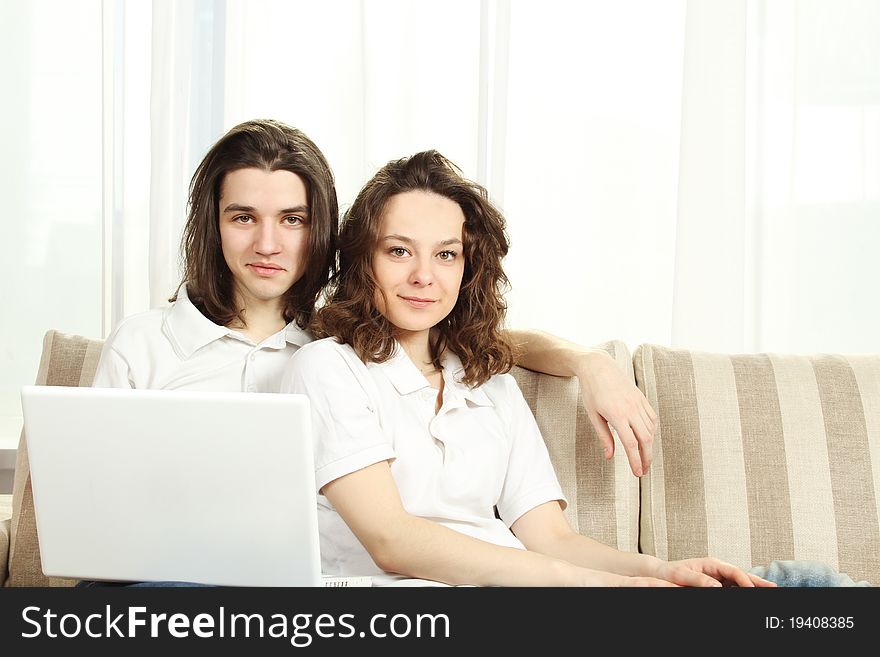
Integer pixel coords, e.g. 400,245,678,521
162,285,312,359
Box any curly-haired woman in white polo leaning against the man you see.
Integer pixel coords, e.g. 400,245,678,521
281,151,772,586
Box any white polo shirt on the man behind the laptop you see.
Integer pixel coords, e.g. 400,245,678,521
92,288,312,392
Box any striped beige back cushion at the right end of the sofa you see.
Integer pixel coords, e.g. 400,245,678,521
634,345,880,584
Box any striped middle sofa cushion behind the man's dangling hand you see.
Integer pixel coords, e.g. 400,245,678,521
512,341,639,552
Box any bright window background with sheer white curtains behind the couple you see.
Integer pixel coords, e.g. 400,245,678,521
0,0,880,447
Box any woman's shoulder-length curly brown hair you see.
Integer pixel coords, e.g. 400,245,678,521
312,150,514,386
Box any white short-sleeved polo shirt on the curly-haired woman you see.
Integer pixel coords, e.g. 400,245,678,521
281,338,565,584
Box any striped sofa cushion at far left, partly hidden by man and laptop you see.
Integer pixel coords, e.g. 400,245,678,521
6,331,103,586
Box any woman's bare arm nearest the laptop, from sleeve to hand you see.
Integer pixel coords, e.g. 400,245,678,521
322,461,667,586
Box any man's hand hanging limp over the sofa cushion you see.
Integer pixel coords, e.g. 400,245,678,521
577,351,657,477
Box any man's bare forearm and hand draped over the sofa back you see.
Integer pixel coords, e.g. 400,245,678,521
507,330,657,477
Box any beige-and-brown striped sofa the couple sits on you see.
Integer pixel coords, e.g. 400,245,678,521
0,331,880,586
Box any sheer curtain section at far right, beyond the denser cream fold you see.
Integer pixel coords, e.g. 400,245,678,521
748,0,880,352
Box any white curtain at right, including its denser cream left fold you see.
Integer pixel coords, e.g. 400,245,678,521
669,0,880,352
